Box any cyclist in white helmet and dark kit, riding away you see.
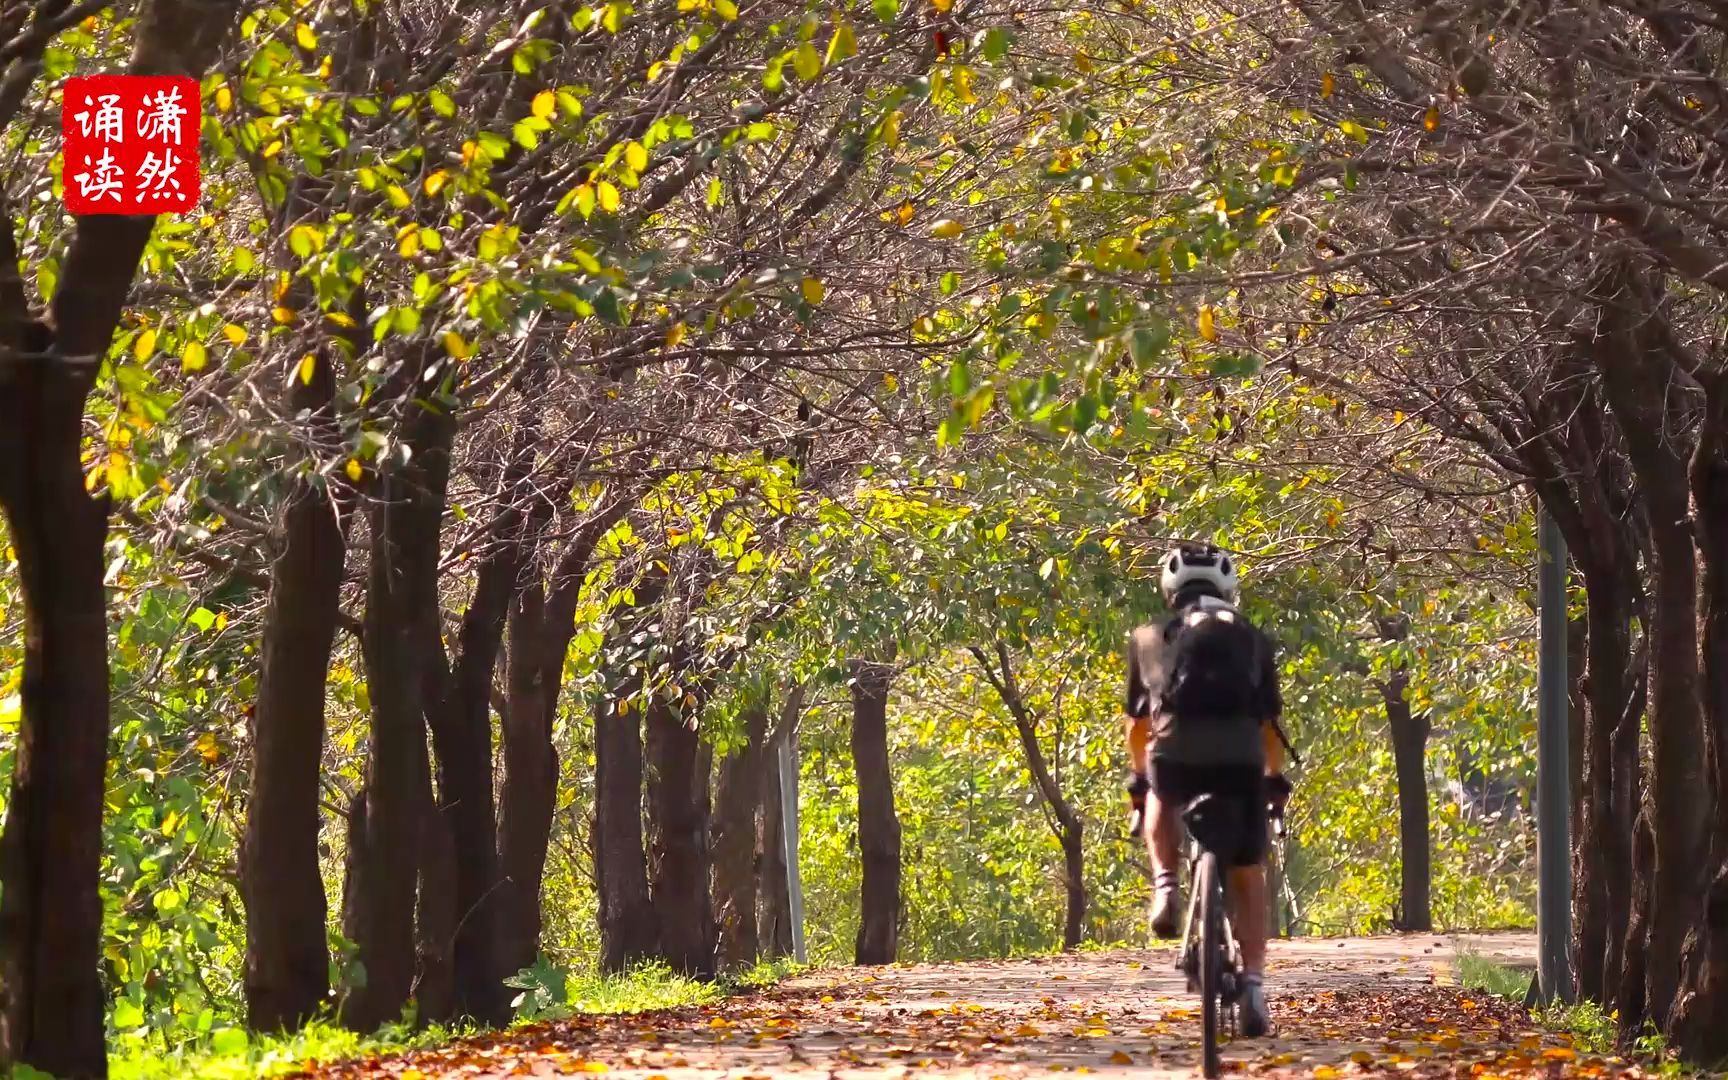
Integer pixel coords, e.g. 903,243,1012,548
1125,543,1289,1039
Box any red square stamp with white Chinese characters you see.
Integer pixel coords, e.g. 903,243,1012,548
60,74,202,214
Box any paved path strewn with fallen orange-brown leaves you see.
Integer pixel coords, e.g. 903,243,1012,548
304,933,1636,1080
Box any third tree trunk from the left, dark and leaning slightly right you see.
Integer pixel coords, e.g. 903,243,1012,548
342,393,456,1032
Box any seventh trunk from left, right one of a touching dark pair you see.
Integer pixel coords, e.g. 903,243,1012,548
645,646,714,976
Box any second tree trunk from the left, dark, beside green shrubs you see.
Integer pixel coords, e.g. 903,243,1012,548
240,353,347,1032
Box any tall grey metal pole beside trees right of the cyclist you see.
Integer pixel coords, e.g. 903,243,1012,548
1536,508,1572,1002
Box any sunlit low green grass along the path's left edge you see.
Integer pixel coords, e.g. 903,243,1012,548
108,961,804,1080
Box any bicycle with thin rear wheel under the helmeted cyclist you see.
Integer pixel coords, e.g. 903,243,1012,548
1177,795,1284,1080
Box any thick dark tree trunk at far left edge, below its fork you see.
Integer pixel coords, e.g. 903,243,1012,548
0,369,109,1077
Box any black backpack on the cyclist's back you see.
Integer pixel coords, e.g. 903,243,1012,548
1163,605,1268,721
